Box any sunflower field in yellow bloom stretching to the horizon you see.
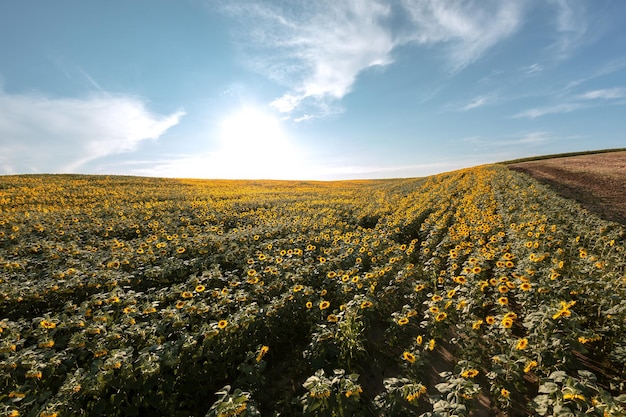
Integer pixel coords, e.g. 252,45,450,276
0,165,626,417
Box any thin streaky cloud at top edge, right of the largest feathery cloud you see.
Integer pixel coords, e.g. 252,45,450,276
402,0,524,70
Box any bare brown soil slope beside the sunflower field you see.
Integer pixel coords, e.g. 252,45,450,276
508,151,626,225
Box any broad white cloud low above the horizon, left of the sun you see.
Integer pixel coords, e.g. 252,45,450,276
0,91,185,173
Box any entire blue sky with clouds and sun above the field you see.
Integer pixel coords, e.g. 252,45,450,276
0,0,626,180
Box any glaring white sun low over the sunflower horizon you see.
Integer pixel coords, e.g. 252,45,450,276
216,108,301,179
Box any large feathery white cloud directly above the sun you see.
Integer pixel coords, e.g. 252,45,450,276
226,0,394,117
